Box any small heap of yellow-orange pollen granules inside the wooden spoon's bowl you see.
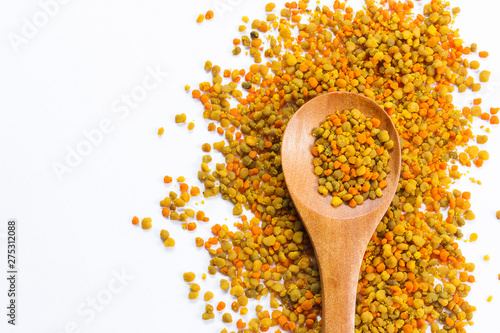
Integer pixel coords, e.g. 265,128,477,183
312,109,394,207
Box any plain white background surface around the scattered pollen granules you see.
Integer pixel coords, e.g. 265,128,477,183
0,0,500,333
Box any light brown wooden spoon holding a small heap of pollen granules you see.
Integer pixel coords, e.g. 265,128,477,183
281,92,401,333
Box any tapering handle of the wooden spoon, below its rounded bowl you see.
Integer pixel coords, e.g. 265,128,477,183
298,212,379,333
